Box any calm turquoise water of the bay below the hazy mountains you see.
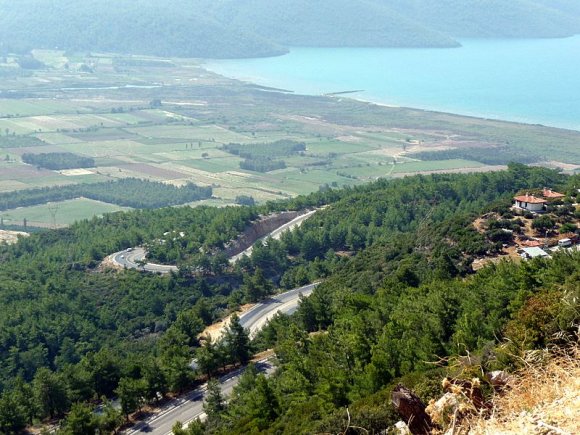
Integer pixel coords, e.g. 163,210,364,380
206,36,580,130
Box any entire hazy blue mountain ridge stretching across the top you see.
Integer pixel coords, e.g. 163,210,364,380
0,0,580,58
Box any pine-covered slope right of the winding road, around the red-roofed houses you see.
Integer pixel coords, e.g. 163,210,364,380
177,165,580,435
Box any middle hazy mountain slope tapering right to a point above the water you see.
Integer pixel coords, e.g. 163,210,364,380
206,0,458,47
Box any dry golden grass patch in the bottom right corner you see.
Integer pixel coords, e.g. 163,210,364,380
464,344,580,435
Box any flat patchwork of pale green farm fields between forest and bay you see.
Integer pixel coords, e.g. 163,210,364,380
0,50,580,226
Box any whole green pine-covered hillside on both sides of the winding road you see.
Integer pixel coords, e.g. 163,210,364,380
0,164,580,434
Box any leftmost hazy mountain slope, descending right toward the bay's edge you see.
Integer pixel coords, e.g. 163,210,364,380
0,0,285,58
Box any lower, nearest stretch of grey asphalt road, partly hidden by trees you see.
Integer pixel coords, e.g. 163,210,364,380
123,284,318,435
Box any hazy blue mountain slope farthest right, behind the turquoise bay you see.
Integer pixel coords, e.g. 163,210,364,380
386,0,580,38
